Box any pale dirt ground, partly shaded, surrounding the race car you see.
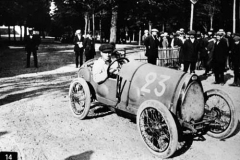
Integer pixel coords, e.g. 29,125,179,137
0,44,240,160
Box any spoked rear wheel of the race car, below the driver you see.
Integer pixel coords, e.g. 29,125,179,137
69,78,91,119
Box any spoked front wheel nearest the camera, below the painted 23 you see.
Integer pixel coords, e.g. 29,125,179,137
137,100,178,158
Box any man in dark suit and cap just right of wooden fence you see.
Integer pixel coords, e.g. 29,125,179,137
183,30,199,73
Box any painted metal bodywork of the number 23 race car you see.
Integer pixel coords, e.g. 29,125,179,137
78,59,203,117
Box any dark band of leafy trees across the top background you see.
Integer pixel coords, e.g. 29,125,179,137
0,0,233,40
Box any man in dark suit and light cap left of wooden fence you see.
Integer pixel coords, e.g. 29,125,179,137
144,29,160,65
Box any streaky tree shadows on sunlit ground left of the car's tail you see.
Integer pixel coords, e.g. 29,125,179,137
0,72,76,105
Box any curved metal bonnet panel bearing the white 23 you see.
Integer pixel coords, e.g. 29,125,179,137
126,64,185,109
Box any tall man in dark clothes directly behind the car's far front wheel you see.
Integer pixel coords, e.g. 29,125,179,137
212,32,228,85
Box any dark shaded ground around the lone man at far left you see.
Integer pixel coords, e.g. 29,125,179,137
0,43,75,78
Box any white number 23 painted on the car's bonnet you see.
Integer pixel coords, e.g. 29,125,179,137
141,72,170,97
